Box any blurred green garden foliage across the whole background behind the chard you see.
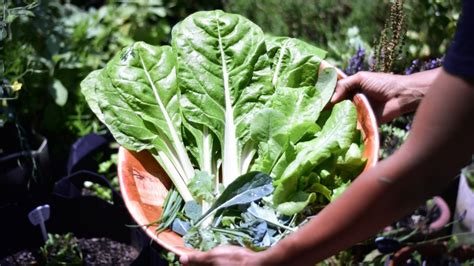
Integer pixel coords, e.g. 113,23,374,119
0,0,461,182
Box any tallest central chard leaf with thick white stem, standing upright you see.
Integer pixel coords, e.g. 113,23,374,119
172,10,272,186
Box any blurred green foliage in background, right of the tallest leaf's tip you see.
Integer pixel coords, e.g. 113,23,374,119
223,0,461,72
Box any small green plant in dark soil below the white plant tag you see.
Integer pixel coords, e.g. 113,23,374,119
40,233,83,265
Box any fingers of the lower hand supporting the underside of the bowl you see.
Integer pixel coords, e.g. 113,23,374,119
179,246,265,266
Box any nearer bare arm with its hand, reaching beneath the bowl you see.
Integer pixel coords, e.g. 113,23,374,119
181,70,474,265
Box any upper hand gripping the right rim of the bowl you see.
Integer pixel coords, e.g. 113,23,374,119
331,71,436,123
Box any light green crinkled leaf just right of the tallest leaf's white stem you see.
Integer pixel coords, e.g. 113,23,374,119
251,68,337,177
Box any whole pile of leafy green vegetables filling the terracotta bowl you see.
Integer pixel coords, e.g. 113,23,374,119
81,11,365,250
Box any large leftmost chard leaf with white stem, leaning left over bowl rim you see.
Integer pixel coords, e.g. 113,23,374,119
83,42,194,201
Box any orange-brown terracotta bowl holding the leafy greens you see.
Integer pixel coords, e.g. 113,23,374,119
118,62,379,255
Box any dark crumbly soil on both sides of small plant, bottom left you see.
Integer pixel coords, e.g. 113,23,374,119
0,238,139,266
